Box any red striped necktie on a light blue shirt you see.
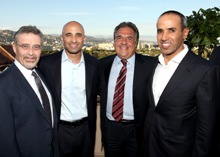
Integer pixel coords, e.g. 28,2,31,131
112,60,127,122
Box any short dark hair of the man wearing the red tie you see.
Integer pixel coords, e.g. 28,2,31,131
113,22,139,43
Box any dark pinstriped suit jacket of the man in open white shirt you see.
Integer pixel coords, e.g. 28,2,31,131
143,51,220,157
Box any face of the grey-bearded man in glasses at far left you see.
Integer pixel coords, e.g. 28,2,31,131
12,33,41,70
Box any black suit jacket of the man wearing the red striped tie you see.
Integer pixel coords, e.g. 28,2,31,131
100,54,154,150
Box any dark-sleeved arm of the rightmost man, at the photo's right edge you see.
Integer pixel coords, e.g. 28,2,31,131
193,67,220,156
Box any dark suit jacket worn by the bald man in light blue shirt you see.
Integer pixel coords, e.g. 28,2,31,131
39,51,99,150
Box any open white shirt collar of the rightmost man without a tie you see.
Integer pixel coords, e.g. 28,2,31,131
159,44,189,65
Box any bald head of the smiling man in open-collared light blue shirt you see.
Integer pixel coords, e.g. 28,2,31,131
61,21,86,54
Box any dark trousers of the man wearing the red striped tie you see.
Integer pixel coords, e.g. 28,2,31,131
104,120,140,157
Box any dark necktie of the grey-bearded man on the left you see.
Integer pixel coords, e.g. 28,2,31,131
32,71,51,123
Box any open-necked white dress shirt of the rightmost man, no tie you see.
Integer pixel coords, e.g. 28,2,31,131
153,45,188,105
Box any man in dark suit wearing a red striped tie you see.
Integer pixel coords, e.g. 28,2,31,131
100,22,153,157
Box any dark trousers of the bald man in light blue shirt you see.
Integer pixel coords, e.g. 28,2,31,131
58,122,94,157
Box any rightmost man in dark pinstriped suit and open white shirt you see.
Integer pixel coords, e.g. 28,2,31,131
143,10,220,157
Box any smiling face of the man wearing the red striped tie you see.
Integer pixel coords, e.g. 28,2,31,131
114,27,137,59
